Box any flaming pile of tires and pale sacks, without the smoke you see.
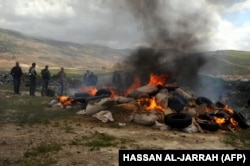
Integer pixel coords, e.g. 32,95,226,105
48,85,249,133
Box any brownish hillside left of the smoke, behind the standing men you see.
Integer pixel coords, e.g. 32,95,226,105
0,29,129,70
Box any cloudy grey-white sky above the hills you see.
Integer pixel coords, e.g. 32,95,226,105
0,0,250,51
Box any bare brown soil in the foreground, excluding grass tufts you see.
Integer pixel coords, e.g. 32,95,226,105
0,91,235,166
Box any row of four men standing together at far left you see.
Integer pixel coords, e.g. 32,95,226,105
10,62,66,96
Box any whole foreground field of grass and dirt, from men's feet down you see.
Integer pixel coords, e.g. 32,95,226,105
0,83,250,166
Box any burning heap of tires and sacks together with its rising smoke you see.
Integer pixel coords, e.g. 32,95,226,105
47,0,249,132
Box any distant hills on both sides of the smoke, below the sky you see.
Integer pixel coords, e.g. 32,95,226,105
0,28,250,78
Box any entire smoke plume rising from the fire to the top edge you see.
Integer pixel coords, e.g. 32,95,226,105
126,0,210,86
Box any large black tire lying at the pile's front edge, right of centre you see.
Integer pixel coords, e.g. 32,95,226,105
164,113,192,128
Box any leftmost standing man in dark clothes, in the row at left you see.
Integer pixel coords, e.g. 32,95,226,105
10,62,23,94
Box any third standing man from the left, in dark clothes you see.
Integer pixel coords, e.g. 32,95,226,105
41,65,50,96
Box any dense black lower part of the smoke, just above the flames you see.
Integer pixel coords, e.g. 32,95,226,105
127,48,206,88
